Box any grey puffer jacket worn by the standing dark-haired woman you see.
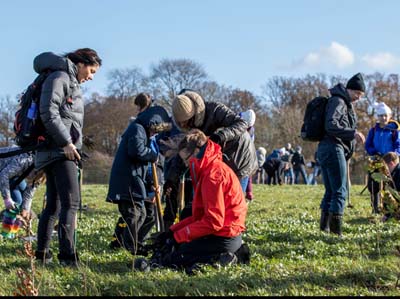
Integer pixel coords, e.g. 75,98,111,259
33,52,84,169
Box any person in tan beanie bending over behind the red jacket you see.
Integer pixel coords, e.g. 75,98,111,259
172,90,257,192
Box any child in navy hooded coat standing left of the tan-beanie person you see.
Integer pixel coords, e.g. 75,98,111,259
106,106,171,255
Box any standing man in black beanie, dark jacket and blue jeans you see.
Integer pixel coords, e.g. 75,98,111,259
317,73,365,236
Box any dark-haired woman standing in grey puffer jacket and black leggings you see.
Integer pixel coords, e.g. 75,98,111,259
33,48,102,266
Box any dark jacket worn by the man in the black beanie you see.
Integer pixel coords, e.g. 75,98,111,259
320,83,357,160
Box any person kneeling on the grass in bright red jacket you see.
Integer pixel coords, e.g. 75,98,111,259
145,129,249,269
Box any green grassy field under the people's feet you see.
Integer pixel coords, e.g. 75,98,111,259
0,185,400,296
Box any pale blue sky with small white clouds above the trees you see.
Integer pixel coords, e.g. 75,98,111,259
0,0,400,99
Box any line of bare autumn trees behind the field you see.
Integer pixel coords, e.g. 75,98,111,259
0,59,400,184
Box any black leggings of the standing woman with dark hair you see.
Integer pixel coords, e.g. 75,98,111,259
37,160,80,255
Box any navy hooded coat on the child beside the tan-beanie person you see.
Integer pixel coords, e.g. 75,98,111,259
106,106,170,203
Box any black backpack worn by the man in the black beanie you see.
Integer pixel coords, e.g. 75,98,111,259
300,96,328,142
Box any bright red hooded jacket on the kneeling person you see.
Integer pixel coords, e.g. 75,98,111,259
170,140,247,243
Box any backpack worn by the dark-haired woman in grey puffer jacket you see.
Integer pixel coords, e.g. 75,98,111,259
14,72,50,148
